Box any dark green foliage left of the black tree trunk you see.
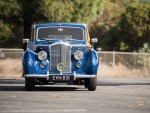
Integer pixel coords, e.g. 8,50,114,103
0,0,23,48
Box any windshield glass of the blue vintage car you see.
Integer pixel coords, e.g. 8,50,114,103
38,27,83,40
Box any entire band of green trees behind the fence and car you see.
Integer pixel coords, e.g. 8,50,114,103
0,0,150,51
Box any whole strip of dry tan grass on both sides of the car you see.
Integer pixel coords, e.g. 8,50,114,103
0,59,150,78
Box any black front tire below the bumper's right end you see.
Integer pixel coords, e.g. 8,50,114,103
85,77,97,91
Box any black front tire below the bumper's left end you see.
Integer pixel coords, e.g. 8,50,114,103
25,78,35,91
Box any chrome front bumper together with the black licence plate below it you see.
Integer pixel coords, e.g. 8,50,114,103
25,72,97,81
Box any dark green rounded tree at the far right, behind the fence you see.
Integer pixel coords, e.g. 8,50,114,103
118,2,150,51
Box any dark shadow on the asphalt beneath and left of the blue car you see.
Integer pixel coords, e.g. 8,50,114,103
0,79,85,91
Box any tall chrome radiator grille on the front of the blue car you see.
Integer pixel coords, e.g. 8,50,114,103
50,44,71,72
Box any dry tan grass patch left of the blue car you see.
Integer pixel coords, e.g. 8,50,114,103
0,59,22,78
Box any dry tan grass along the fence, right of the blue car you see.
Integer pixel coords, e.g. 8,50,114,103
98,64,150,78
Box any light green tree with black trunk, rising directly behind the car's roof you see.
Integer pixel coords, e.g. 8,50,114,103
23,0,103,38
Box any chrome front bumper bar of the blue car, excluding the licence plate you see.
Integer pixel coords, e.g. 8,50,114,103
25,72,97,80
